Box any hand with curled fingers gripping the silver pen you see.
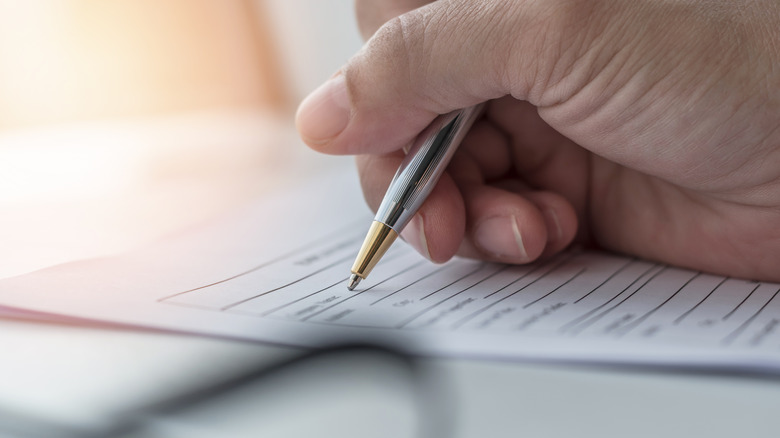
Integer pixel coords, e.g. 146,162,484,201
297,0,780,280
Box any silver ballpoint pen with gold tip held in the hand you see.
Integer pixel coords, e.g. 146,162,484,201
347,104,484,290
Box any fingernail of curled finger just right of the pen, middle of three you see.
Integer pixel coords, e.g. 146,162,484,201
474,216,528,260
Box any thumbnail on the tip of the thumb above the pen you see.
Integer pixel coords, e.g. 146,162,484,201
296,75,352,143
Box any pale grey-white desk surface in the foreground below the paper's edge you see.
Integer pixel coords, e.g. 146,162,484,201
0,320,780,437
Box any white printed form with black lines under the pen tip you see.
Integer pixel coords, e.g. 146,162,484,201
0,169,780,373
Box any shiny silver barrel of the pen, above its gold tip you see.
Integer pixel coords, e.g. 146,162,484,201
375,105,482,233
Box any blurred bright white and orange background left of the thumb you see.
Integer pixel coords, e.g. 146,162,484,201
0,0,361,277
